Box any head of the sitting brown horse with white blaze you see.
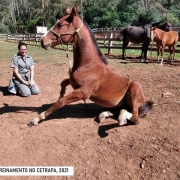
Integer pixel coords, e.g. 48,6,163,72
41,6,83,49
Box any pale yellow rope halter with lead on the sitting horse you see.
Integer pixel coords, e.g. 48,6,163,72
49,21,83,73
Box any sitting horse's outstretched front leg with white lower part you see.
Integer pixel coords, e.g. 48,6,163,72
28,89,89,126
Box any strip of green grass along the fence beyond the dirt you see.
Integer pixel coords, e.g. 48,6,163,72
0,41,180,63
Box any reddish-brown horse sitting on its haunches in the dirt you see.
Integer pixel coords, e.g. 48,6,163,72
29,6,152,126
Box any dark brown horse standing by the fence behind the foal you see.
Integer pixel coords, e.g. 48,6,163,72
117,22,171,61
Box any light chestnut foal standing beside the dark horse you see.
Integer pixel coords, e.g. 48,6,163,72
151,27,179,65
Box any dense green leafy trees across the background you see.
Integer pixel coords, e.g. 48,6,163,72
0,0,180,33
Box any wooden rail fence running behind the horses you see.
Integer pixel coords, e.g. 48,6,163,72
0,27,180,54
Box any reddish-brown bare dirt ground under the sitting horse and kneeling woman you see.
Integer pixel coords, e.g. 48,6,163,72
0,56,180,180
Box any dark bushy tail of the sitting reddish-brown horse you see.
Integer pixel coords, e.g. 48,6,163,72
138,101,153,117
